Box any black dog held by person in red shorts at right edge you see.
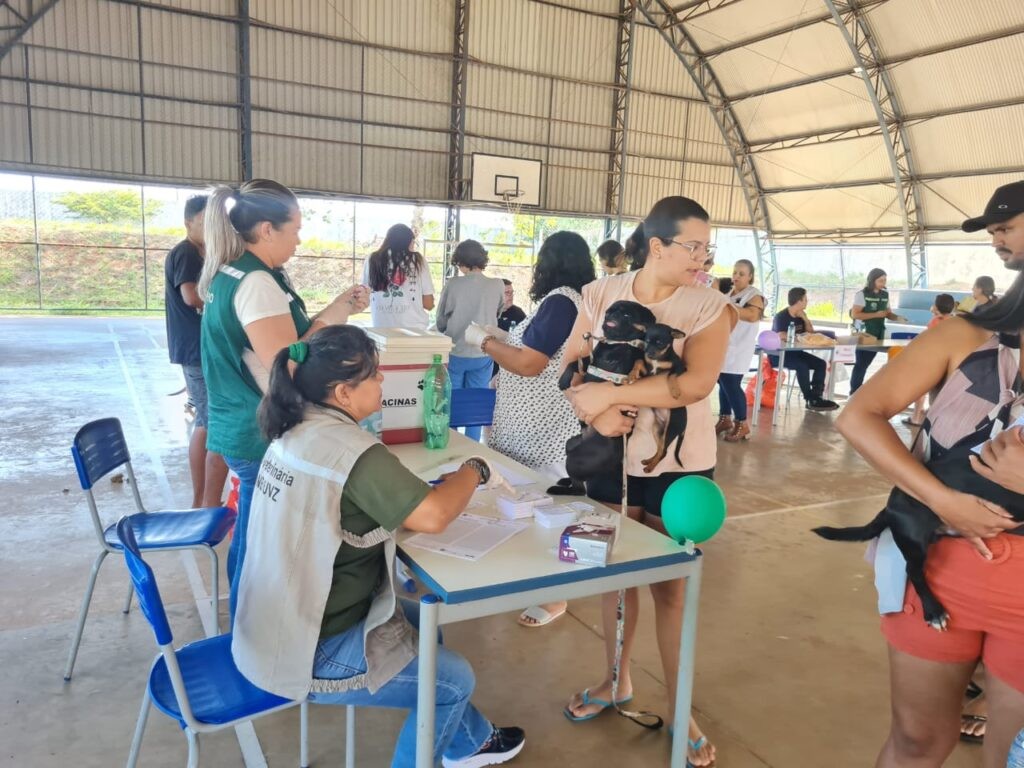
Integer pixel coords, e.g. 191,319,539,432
814,433,1024,632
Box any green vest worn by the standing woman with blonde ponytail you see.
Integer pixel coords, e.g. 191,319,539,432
202,251,311,461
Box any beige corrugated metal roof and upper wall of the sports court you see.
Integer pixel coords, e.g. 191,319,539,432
0,0,1024,243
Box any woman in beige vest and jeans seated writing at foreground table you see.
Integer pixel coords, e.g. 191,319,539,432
231,326,525,768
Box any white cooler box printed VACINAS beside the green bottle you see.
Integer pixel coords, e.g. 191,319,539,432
366,328,452,445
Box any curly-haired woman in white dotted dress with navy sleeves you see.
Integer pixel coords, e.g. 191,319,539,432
467,232,596,628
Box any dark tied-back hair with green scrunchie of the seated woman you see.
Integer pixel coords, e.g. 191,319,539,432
256,326,378,440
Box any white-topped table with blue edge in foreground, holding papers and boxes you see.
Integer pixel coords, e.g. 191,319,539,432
390,432,702,768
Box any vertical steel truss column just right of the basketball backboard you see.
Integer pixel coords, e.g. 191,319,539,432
604,0,637,241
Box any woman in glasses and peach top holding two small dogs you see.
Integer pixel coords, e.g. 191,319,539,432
564,197,736,766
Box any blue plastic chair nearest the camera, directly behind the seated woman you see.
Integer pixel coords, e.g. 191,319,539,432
116,513,309,768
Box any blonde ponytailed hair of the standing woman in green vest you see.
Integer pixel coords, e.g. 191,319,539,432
199,178,299,301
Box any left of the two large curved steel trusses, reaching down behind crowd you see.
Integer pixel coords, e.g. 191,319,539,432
637,0,778,307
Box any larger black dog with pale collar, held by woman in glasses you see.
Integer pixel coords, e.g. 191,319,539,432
548,301,656,495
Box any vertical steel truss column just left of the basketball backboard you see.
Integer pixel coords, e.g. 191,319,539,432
444,0,469,274
